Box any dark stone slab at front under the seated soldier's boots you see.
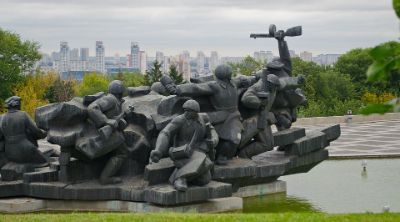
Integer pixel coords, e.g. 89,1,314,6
145,181,232,206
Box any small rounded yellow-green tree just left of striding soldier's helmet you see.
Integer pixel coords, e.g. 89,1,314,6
77,72,110,96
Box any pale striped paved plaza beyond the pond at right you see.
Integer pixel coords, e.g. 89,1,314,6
299,120,400,158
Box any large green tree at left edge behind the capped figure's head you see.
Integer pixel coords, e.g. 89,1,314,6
0,28,41,111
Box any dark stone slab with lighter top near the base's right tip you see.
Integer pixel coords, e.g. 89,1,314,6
285,131,329,156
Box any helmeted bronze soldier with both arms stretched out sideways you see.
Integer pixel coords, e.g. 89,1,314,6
161,65,255,165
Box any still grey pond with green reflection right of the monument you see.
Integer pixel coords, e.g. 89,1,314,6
243,159,400,213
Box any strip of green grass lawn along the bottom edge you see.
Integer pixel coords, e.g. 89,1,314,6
0,213,400,222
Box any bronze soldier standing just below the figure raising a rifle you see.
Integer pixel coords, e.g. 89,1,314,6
238,73,304,158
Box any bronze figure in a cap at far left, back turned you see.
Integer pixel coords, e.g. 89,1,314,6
0,96,48,165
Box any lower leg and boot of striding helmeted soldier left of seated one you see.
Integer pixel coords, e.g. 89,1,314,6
100,144,128,184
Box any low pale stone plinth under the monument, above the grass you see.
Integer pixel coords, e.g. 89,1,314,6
0,197,243,213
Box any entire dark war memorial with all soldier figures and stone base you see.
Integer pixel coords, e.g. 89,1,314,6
0,25,340,212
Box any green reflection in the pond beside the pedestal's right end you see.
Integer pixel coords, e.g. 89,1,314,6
243,193,321,213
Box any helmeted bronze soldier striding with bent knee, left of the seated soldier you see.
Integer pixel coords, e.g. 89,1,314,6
88,80,129,184
